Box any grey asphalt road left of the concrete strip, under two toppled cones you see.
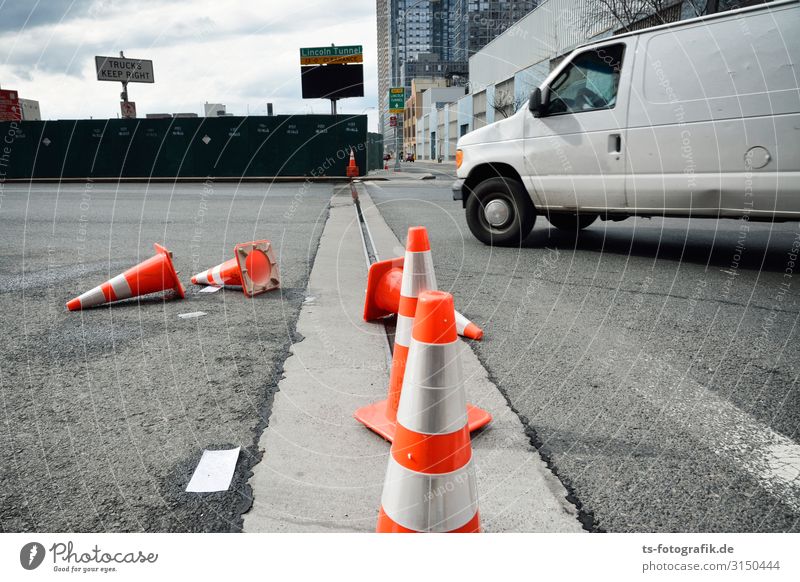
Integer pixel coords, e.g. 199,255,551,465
0,183,332,532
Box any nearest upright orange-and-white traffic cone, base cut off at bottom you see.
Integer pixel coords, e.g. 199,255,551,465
376,291,480,533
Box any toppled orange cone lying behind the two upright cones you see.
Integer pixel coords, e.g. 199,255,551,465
364,257,483,340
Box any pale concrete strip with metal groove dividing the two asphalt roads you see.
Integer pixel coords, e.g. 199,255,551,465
244,187,582,532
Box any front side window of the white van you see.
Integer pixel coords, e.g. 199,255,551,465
547,44,625,115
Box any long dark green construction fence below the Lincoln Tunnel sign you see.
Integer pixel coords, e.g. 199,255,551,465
0,115,383,180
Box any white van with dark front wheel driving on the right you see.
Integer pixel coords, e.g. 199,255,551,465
453,0,800,244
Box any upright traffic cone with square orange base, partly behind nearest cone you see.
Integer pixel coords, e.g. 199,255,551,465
354,226,492,442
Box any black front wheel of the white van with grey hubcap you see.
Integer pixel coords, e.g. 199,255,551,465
466,178,536,246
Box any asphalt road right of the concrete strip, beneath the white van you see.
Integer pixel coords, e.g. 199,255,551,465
367,178,800,532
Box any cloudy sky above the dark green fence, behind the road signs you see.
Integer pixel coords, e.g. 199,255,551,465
0,0,377,129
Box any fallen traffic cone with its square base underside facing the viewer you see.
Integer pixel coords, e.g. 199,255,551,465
192,240,281,297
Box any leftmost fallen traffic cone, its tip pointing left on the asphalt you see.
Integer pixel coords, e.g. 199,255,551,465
67,244,185,311
